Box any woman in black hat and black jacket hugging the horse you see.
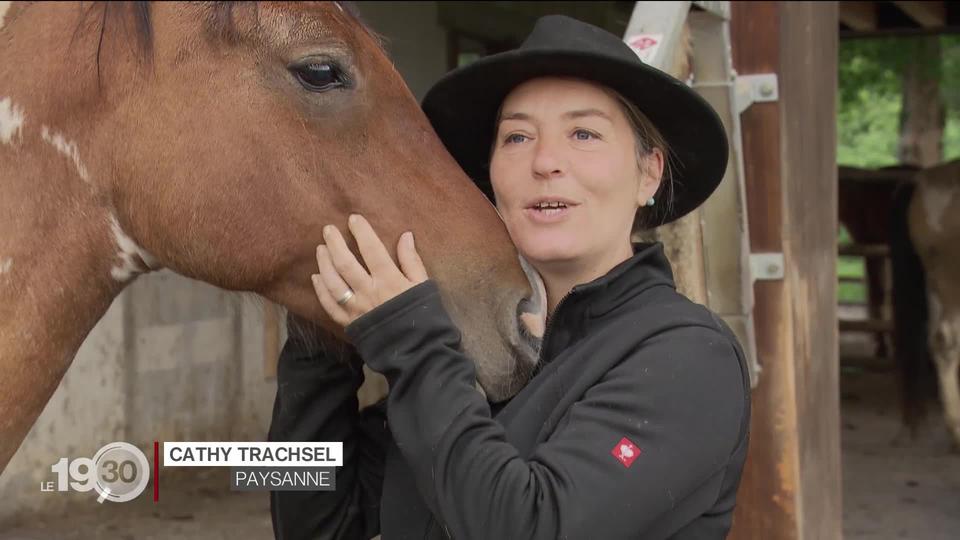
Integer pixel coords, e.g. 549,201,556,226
271,16,750,540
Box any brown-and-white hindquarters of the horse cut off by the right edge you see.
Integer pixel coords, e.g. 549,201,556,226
908,160,960,448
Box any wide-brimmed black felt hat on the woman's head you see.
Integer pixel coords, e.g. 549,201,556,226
422,15,728,226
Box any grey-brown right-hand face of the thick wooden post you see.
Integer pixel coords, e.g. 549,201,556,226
780,2,843,539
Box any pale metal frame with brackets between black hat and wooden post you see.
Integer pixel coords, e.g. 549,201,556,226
623,1,772,387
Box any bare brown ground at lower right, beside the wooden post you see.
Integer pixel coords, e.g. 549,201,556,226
841,344,960,540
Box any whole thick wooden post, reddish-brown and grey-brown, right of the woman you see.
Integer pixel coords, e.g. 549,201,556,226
731,2,842,540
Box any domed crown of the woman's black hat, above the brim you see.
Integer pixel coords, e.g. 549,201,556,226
519,15,643,64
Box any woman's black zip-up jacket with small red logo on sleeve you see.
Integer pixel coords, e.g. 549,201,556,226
271,243,750,540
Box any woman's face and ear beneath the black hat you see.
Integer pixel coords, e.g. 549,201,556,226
490,78,663,271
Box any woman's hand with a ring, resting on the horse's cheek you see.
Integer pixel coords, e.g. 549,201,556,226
310,214,427,326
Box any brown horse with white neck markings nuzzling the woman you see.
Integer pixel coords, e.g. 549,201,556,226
0,2,543,471
